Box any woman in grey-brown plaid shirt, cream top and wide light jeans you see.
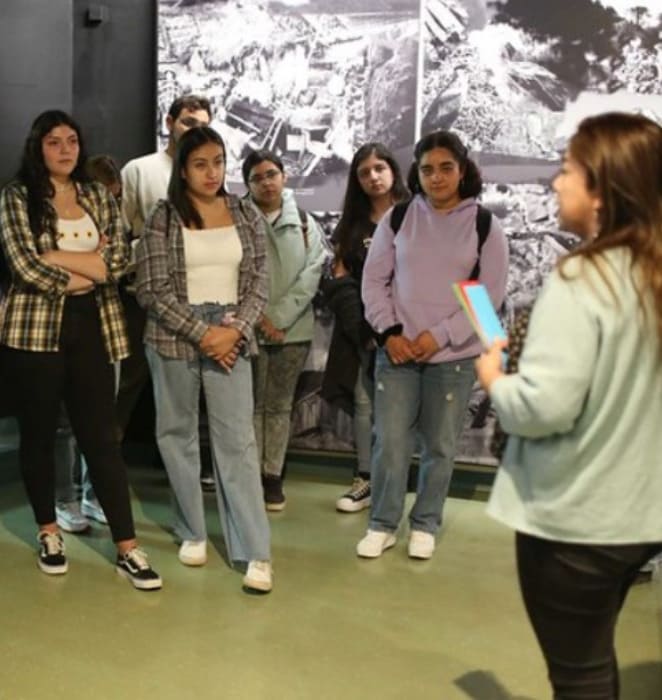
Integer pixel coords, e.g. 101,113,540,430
136,126,272,593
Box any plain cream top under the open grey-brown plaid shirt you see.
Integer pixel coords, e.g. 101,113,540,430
182,226,243,304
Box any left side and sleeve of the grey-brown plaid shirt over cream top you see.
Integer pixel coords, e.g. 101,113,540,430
136,200,207,360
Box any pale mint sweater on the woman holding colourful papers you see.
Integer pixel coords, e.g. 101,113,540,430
488,248,662,544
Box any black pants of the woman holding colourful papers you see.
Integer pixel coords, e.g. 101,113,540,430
516,532,662,700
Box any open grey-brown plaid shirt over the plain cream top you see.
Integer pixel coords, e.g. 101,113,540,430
136,194,268,360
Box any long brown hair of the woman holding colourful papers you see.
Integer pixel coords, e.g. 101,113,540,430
560,112,662,346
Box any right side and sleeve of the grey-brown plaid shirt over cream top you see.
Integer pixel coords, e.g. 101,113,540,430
227,195,269,352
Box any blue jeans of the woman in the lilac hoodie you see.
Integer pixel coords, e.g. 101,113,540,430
369,349,475,534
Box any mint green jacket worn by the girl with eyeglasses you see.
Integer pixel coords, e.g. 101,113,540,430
253,189,327,344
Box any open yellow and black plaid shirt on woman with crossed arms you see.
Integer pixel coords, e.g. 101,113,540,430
0,181,129,362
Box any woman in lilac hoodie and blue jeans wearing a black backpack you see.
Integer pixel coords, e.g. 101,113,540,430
357,131,508,559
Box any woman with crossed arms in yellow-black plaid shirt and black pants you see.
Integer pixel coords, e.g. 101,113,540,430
0,110,161,590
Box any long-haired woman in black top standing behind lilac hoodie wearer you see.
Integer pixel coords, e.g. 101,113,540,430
322,143,408,513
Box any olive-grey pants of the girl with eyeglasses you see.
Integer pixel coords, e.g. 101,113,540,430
253,342,310,478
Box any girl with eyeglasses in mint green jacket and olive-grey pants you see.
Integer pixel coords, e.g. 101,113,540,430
242,150,326,512
